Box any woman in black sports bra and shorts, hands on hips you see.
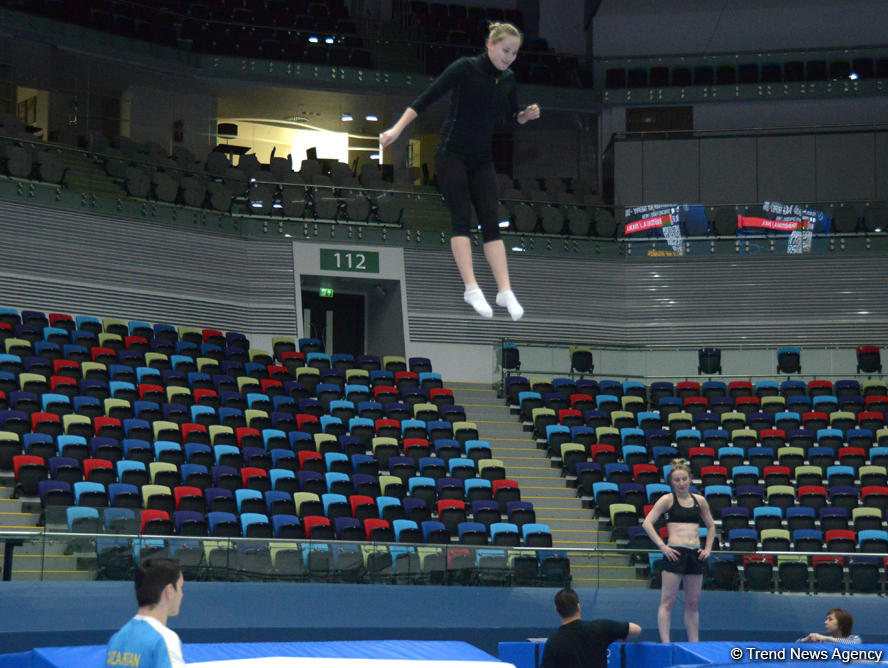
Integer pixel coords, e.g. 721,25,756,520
642,459,715,642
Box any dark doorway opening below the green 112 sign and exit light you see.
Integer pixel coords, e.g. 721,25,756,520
302,290,365,357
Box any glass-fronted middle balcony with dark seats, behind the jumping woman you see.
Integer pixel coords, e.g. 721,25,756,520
0,130,888,260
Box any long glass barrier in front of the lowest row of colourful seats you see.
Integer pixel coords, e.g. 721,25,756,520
0,530,888,593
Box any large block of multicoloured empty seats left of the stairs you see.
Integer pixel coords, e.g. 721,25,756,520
0,309,553,584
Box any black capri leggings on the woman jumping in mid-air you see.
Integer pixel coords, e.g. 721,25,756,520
435,153,500,243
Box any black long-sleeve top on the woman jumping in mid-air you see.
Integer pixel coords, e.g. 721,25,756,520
410,51,519,157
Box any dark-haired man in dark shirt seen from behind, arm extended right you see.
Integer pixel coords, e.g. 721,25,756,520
541,589,641,668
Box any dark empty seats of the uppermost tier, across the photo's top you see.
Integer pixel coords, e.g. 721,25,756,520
17,0,888,94
